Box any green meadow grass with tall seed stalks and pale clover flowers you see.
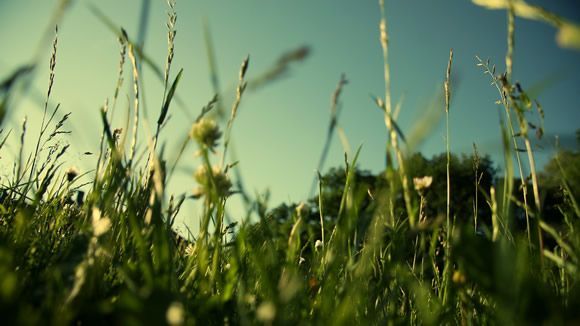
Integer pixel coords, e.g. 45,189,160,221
0,0,580,325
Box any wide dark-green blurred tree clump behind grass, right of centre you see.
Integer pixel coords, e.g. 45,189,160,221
256,153,495,244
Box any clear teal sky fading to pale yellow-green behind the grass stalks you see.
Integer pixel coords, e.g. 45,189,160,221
0,0,580,233
